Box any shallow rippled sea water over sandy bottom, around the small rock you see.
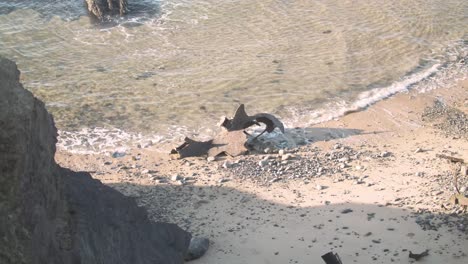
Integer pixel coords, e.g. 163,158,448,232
0,0,468,152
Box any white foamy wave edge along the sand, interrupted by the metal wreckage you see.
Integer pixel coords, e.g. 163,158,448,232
53,57,468,154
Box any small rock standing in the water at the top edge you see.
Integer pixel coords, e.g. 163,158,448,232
86,0,127,20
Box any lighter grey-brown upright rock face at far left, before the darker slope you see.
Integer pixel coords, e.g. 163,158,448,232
0,56,65,263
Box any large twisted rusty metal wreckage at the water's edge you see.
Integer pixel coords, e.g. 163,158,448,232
171,104,284,159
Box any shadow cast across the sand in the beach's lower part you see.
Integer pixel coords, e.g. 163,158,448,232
110,183,468,264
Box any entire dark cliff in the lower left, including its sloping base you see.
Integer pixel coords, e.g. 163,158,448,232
0,58,190,264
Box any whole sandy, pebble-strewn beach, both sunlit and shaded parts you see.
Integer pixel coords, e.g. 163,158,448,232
56,80,468,264
